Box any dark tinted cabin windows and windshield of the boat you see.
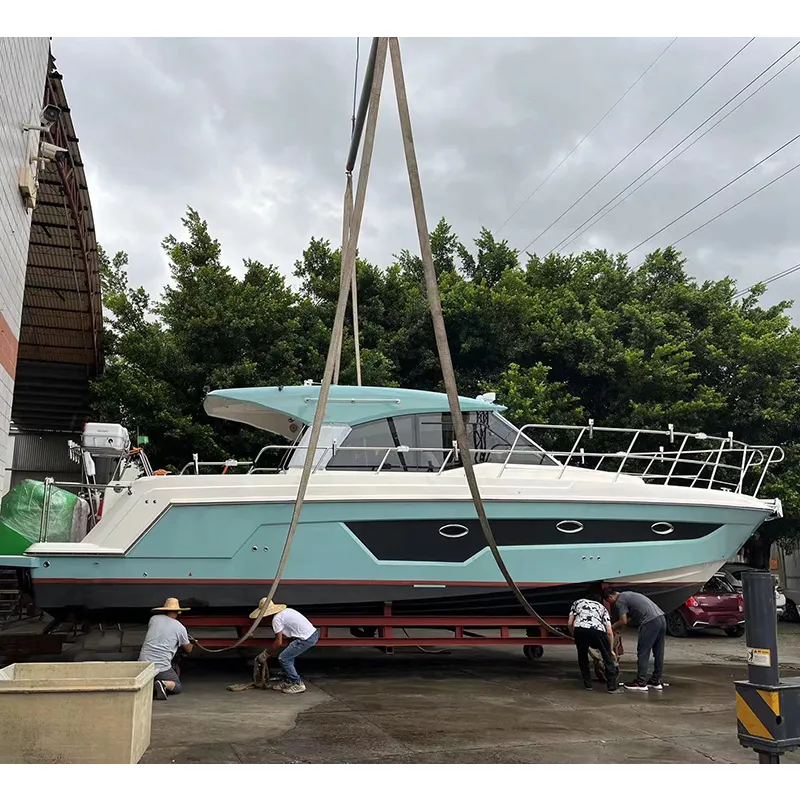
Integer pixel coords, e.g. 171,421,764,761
326,411,558,472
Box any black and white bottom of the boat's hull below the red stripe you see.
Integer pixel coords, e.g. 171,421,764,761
28,562,721,622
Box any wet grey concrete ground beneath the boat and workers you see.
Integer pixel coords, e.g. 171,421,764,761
123,624,800,764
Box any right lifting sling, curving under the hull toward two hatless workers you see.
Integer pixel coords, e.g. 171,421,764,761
389,36,570,638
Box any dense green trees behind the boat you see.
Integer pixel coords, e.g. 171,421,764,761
94,209,800,552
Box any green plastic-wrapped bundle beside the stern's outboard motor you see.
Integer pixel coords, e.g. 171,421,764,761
0,481,78,556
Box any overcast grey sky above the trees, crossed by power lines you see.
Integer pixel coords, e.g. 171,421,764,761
52,38,800,313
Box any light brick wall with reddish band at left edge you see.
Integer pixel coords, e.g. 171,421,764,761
0,36,50,495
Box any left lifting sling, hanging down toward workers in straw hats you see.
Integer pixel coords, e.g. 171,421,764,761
191,38,386,653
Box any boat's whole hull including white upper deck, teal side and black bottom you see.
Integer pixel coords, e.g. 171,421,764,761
12,473,773,621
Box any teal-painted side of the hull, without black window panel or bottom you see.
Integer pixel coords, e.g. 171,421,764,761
36,501,766,584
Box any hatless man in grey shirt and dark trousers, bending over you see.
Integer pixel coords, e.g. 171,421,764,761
606,589,667,692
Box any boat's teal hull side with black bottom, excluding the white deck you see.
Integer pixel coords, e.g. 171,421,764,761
20,502,765,621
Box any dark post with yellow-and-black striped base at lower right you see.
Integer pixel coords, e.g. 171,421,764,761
735,571,800,764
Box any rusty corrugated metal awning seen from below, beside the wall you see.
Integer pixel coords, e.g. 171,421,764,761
11,55,103,430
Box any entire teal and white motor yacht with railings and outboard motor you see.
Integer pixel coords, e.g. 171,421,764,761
0,382,782,622
